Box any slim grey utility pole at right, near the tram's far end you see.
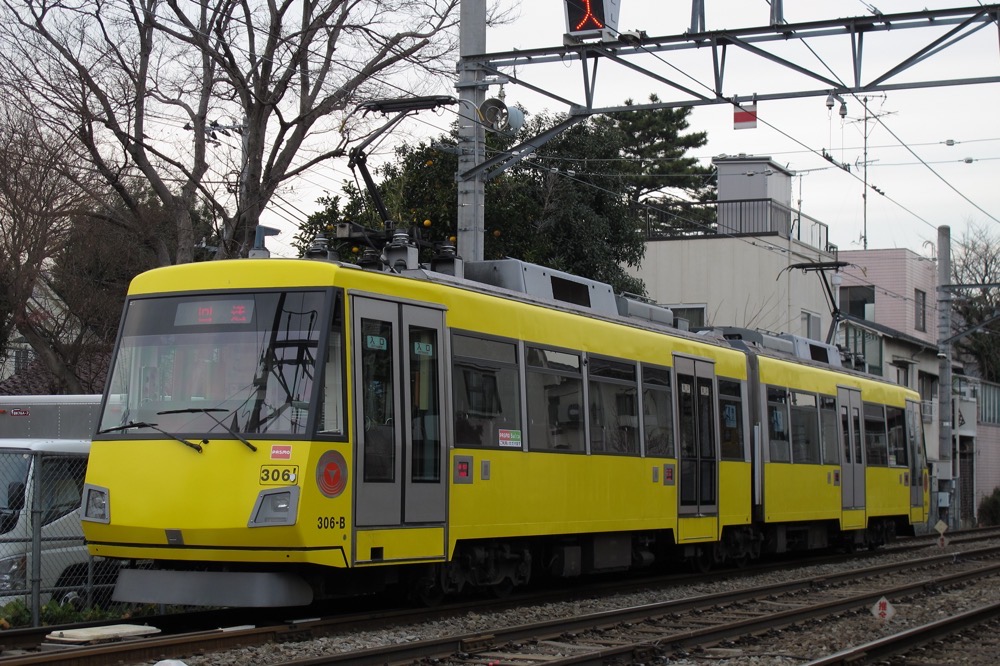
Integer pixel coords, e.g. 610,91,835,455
938,225,961,529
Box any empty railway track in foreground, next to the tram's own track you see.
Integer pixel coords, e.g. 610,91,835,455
386,549,1000,666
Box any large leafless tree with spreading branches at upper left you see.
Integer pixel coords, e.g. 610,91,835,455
0,0,459,263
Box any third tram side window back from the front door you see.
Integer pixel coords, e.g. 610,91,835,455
587,356,639,456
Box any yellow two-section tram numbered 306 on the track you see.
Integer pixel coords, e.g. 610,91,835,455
83,259,928,606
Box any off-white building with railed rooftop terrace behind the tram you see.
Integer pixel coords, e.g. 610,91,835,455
632,156,836,340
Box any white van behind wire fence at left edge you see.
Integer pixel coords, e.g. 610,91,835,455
0,395,114,611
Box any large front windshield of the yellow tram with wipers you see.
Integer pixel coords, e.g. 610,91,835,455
100,291,339,436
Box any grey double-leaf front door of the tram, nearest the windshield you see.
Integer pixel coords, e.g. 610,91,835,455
352,296,447,528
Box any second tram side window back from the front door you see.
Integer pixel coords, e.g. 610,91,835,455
526,347,586,453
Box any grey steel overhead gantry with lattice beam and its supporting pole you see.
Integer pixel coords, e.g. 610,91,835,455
457,0,1000,260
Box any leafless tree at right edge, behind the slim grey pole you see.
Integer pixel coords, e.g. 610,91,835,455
951,225,1000,382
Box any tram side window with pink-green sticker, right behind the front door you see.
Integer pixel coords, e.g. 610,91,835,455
452,333,521,449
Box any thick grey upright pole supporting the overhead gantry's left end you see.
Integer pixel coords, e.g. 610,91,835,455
455,0,486,261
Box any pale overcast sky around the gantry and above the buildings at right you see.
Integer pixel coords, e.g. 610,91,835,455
268,0,1000,255
